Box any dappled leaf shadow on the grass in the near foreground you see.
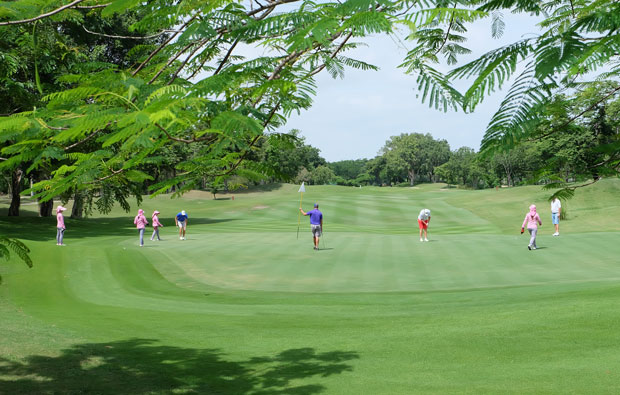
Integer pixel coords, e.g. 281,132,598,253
0,339,359,395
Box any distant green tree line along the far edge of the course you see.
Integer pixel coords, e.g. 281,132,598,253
269,82,620,189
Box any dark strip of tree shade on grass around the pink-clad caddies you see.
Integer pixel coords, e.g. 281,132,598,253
0,216,235,241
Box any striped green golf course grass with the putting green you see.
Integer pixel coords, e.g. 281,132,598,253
0,179,620,395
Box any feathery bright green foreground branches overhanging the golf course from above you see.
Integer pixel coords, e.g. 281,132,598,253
0,0,620,204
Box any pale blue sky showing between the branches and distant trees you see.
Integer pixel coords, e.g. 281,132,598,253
278,14,538,162
